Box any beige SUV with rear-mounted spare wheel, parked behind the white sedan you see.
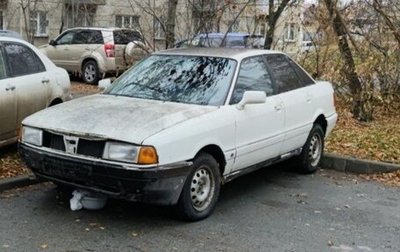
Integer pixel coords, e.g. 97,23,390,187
40,27,147,84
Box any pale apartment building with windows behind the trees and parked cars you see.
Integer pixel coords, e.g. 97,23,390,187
0,0,312,53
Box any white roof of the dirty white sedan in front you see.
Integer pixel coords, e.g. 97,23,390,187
154,47,283,61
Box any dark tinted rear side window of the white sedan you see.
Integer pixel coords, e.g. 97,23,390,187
265,54,302,93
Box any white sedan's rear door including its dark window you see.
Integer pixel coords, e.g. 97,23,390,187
265,54,316,153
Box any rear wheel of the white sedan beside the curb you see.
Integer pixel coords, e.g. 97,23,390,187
295,124,325,174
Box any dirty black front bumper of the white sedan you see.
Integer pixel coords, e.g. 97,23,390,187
19,144,192,205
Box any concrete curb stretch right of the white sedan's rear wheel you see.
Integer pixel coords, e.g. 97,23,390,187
321,153,400,174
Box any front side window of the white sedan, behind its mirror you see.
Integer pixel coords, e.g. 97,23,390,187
230,56,273,104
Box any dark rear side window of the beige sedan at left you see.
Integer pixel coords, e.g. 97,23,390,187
4,43,46,76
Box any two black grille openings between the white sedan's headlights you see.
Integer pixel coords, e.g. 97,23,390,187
43,131,106,158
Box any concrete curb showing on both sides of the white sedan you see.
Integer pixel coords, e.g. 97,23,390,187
0,153,400,192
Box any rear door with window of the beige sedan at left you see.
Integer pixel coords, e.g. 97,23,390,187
3,42,51,126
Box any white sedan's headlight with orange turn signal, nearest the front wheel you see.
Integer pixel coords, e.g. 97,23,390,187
103,142,158,164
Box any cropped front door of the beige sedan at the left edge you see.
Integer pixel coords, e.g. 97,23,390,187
0,45,17,142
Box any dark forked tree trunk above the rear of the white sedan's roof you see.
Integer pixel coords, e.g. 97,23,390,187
264,0,291,49
